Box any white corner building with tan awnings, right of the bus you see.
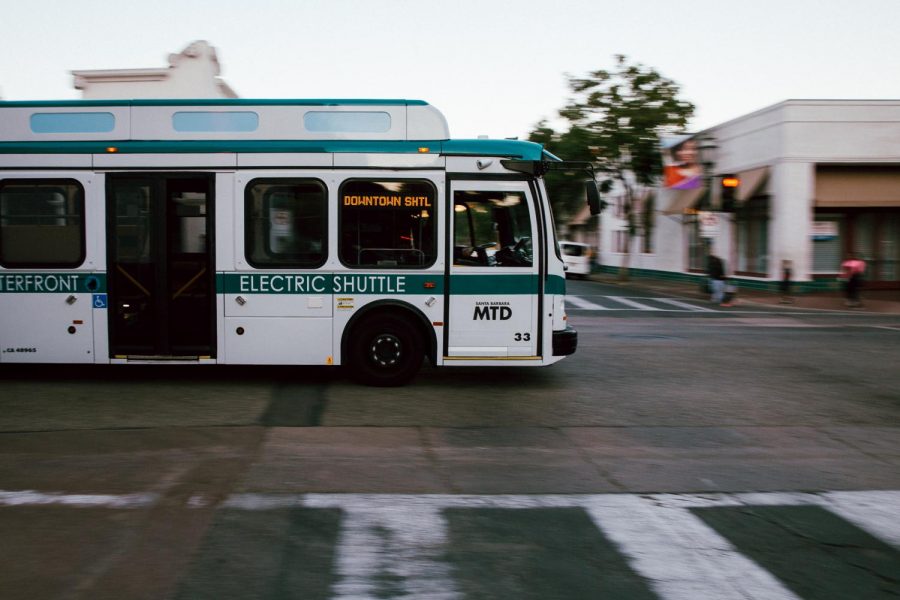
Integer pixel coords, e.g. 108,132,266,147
599,100,900,289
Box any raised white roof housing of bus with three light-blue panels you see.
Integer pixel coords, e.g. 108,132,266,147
0,99,450,142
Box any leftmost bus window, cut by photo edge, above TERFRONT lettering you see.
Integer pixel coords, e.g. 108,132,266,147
0,179,85,268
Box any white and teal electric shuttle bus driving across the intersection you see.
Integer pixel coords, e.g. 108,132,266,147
0,99,590,385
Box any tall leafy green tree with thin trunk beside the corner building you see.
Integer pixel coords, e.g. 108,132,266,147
530,54,694,279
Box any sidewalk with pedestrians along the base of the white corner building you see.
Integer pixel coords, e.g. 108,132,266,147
590,273,900,315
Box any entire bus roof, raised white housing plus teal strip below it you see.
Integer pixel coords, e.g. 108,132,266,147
0,98,546,161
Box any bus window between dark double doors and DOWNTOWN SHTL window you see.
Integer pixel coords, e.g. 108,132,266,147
245,179,328,269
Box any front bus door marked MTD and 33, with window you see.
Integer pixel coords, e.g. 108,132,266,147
447,181,540,359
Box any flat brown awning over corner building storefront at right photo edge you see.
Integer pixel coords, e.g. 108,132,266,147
815,165,900,207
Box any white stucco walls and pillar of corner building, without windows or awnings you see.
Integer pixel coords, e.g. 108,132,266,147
601,100,900,281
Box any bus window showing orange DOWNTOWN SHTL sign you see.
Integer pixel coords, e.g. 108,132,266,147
338,179,437,269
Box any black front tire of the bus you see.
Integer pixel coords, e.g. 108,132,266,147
349,315,425,387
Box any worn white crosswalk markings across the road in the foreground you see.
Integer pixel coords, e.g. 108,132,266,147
0,490,900,600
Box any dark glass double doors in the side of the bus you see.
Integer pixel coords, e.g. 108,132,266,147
107,174,215,358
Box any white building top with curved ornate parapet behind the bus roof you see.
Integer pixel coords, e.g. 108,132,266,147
72,40,238,100
